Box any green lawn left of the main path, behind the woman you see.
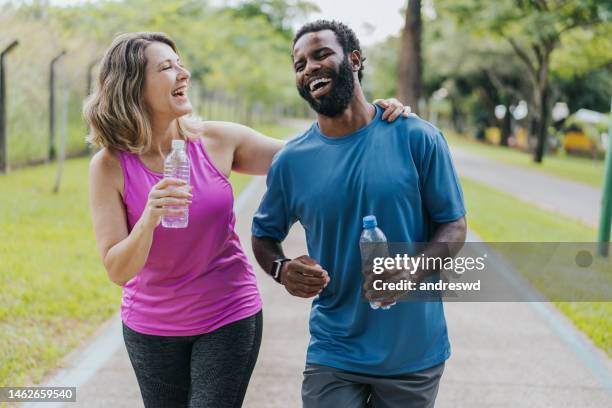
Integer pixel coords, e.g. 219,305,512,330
0,122,302,386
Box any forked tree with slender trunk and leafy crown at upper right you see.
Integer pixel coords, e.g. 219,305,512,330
448,0,612,163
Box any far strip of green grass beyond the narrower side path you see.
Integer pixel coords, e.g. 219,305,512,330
444,130,604,188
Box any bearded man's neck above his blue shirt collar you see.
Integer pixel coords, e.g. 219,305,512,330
317,87,376,137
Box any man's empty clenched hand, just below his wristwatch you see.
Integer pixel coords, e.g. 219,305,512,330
281,255,329,298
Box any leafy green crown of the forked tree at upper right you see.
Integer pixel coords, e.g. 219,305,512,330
438,0,612,97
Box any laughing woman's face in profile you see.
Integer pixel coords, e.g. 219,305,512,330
144,42,192,119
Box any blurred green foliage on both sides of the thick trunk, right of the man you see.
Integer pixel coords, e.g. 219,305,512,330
366,0,612,139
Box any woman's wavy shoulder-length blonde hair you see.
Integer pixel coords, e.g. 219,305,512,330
83,32,198,154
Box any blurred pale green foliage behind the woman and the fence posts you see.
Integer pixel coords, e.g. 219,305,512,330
0,0,316,164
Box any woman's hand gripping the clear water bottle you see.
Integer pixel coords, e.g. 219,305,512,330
141,178,193,229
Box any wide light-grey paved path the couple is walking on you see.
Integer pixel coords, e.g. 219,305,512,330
36,135,612,408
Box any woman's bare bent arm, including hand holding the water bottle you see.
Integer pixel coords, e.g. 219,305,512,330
89,149,189,286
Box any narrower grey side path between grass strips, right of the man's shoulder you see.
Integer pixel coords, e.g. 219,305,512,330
452,147,601,226
